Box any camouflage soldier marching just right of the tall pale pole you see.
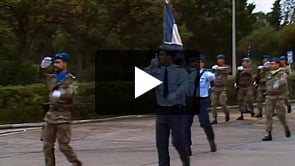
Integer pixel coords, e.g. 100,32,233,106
234,57,254,120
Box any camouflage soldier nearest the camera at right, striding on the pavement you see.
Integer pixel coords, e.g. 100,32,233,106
262,58,291,141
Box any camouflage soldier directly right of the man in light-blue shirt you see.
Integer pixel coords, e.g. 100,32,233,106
211,54,229,124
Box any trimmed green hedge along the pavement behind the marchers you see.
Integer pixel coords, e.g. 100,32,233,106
0,76,295,124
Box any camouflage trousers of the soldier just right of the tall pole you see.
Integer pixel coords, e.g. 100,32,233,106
237,87,254,112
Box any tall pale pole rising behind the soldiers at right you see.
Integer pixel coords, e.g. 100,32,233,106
232,0,237,76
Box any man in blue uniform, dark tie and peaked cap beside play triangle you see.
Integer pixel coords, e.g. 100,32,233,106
145,44,190,166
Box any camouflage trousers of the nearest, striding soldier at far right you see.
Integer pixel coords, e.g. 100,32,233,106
265,98,289,132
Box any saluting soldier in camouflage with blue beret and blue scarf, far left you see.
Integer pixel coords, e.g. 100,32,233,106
39,53,82,166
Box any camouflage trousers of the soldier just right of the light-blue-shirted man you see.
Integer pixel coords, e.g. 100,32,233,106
210,90,229,118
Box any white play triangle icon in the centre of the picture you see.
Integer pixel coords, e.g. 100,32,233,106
135,66,162,98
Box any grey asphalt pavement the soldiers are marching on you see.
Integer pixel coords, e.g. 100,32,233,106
0,105,295,166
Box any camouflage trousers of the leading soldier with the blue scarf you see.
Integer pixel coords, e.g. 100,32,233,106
42,123,77,166
